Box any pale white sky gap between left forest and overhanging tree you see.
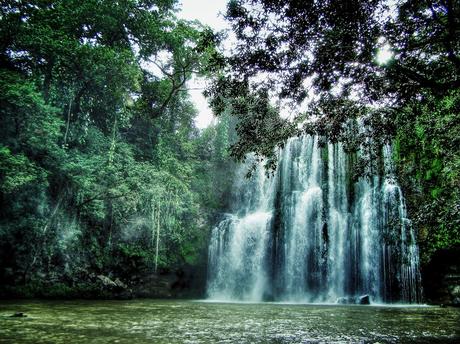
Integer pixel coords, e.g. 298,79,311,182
177,0,228,129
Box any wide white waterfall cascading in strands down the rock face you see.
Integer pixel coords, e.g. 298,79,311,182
207,136,421,303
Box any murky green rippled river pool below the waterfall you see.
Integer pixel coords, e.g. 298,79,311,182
0,300,460,344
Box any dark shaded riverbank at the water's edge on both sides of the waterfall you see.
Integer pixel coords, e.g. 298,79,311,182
0,248,460,307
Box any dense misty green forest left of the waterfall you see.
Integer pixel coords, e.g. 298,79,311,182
0,0,231,296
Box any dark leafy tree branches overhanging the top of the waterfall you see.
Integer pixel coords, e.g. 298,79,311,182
208,0,460,165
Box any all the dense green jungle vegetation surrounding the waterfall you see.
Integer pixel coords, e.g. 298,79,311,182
0,0,460,296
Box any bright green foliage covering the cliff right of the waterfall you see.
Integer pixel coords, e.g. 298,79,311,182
395,90,460,261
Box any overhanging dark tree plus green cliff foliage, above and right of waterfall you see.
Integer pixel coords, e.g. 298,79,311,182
207,0,460,262
